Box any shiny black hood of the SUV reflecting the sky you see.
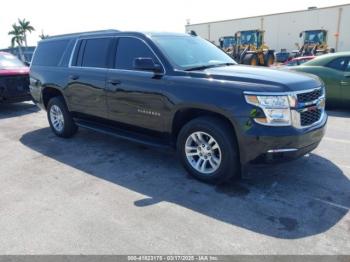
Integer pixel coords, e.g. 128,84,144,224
192,65,322,92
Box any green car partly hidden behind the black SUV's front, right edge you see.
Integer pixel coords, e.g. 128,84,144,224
292,52,350,108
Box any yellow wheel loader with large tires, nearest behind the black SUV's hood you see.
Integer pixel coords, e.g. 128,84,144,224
232,29,275,66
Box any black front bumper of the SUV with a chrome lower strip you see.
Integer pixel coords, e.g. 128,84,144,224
238,113,327,164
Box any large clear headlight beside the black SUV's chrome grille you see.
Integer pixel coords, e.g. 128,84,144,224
245,95,291,126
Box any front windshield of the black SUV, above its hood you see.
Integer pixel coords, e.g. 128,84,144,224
152,36,236,70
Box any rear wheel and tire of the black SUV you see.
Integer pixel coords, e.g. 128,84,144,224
47,97,78,138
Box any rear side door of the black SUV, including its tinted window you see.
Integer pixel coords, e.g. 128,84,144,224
66,37,114,118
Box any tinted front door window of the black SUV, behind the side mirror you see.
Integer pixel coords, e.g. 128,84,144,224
115,37,158,70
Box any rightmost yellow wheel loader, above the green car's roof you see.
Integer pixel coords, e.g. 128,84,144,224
293,29,334,57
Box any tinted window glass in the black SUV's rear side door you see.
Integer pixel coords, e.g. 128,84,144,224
81,38,113,68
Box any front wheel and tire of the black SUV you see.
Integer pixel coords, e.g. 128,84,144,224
177,117,240,183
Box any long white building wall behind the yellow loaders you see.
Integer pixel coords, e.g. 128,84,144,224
186,4,350,51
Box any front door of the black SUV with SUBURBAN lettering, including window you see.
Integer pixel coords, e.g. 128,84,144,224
107,37,169,131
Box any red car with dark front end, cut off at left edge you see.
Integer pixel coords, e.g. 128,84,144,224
0,52,32,104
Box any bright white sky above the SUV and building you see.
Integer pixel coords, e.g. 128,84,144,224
0,0,350,48
